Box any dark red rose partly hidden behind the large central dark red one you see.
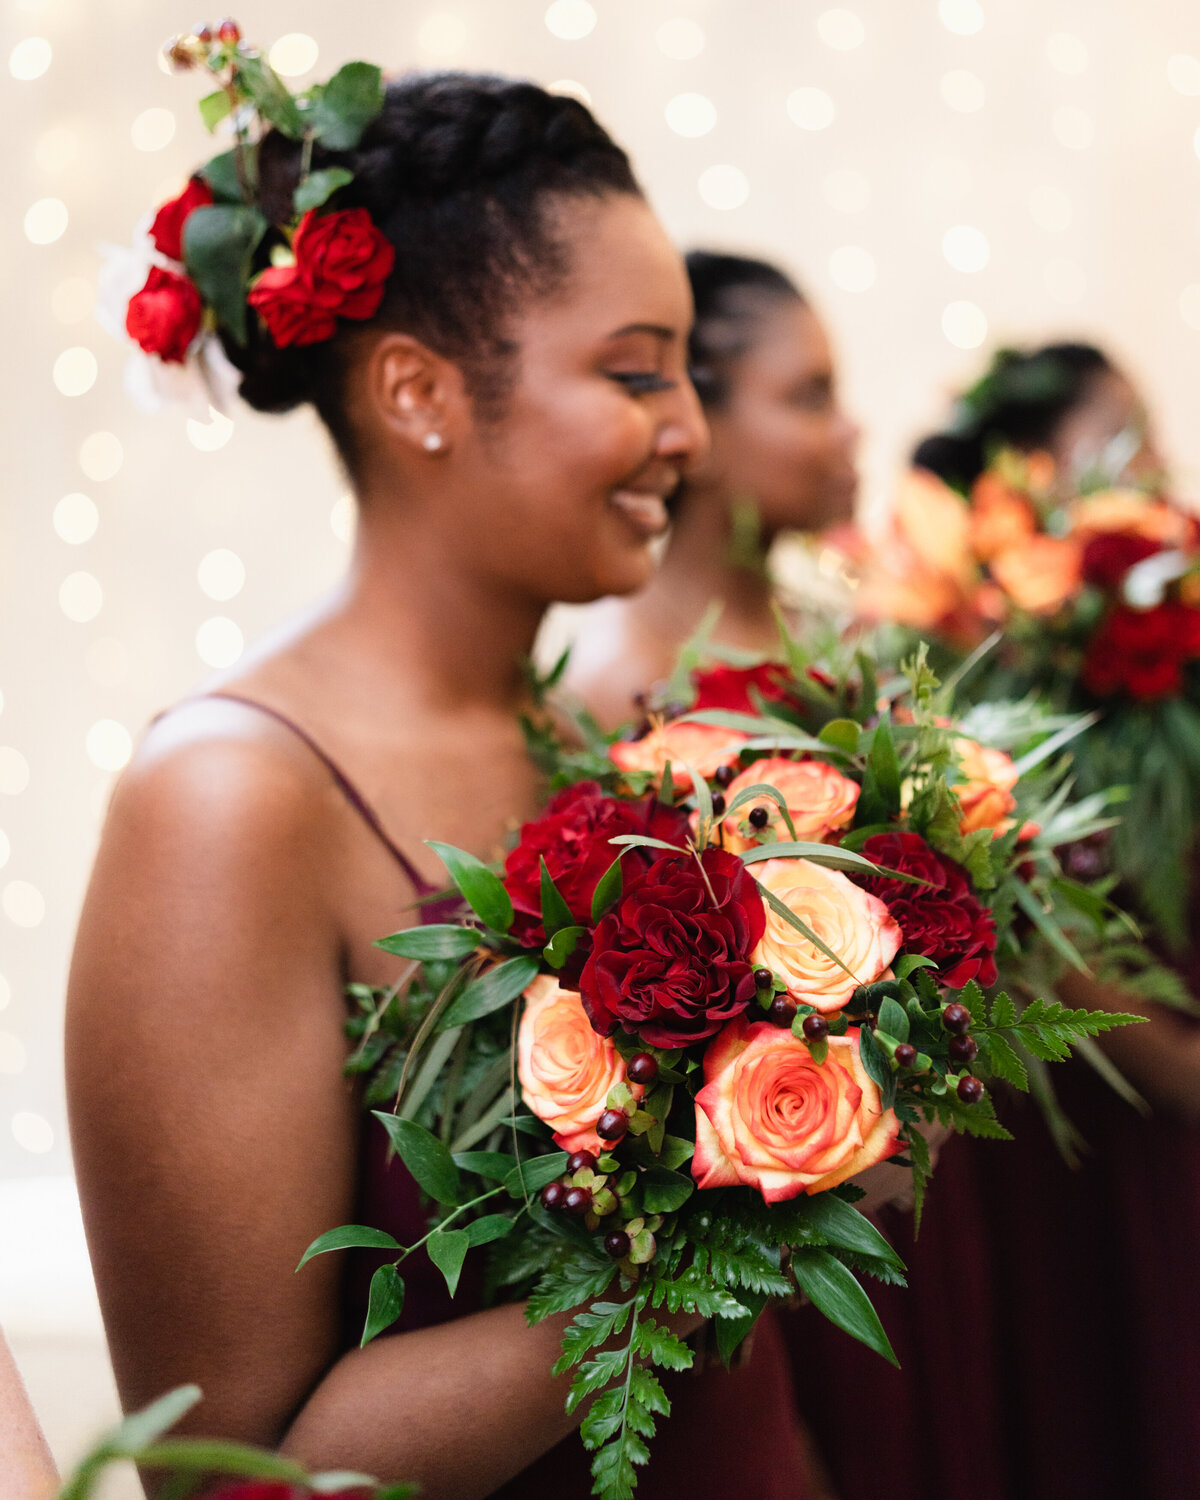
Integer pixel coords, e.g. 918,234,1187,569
504,782,690,947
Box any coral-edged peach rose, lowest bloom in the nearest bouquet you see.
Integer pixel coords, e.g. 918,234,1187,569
692,1020,902,1203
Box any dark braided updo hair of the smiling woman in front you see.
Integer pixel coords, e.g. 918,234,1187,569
230,72,641,468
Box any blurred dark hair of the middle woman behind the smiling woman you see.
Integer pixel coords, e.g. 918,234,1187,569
686,251,804,408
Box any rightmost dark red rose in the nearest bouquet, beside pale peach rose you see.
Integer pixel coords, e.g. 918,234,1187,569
854,834,996,990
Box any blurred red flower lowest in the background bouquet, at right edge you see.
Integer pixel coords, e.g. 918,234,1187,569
1082,600,1200,701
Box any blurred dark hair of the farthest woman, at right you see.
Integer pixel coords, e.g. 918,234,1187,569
912,344,1113,488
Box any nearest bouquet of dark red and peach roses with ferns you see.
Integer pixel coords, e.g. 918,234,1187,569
302,639,1133,1500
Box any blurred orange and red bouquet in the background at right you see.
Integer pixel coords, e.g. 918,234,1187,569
860,453,1200,947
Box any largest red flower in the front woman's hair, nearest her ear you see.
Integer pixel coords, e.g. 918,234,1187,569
248,209,396,350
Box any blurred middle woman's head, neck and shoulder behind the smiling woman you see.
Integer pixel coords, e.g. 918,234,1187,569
567,251,858,728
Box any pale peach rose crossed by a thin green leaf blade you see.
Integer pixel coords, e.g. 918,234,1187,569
750,860,902,1011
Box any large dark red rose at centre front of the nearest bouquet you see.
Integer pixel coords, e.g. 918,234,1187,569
579,849,765,1047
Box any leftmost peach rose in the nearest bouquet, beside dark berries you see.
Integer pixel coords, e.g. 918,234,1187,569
516,974,644,1155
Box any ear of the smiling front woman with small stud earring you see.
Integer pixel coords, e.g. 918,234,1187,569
363,333,471,456
